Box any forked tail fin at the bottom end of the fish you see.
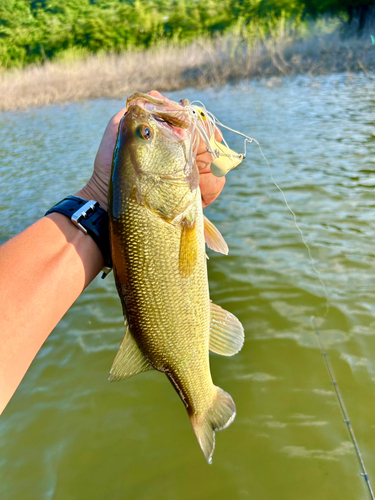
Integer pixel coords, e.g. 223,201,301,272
190,387,236,464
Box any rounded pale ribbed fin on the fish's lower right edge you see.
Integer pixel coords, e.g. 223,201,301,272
210,302,245,356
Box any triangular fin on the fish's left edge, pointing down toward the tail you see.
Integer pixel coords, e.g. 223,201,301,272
108,321,154,382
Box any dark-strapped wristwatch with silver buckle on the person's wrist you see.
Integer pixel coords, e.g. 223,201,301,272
45,196,112,278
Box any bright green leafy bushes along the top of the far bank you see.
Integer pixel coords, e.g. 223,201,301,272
0,0,375,68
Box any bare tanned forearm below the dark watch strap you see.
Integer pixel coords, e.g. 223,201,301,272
0,208,103,413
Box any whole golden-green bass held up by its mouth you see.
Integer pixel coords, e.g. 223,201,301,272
108,93,244,463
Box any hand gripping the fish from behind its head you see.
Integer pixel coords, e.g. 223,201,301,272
76,90,225,210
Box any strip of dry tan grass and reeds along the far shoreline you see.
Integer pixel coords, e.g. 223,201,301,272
0,19,375,111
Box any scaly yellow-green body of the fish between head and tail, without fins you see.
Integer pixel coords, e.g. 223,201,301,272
112,191,215,414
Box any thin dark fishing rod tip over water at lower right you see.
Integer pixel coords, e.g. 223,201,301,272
311,316,375,500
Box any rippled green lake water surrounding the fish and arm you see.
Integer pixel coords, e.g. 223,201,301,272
0,75,375,500
